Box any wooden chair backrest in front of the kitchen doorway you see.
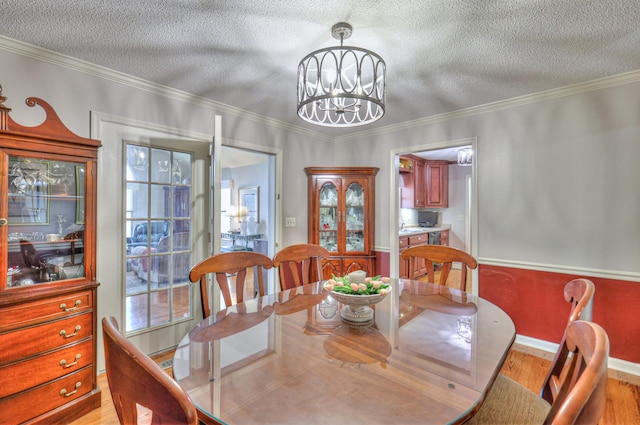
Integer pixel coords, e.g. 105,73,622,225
402,245,478,291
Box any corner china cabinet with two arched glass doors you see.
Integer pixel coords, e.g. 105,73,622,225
305,167,378,279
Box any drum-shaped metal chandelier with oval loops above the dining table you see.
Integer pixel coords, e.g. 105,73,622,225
298,22,386,127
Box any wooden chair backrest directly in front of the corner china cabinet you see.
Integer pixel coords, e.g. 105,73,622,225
273,244,329,290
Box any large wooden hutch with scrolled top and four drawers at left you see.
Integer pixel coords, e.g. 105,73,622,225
0,87,101,424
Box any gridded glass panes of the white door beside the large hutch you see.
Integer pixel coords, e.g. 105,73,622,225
125,144,193,331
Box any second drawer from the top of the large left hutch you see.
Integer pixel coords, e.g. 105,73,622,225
0,312,93,364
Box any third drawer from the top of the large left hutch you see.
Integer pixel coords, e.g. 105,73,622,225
0,339,93,398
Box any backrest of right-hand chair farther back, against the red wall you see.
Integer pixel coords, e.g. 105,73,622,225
540,279,595,403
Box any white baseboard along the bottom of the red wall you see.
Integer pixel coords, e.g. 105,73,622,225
513,335,640,385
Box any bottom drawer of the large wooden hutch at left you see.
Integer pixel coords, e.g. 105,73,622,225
0,366,95,424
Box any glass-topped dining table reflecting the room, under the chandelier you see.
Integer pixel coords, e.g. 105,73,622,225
173,279,515,425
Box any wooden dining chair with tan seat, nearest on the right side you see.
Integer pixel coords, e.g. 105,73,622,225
466,320,609,425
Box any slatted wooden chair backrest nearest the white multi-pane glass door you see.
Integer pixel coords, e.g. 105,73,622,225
189,251,273,318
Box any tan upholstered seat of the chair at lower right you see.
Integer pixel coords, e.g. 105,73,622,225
466,374,551,425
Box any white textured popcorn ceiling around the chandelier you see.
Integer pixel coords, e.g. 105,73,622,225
0,0,640,136
